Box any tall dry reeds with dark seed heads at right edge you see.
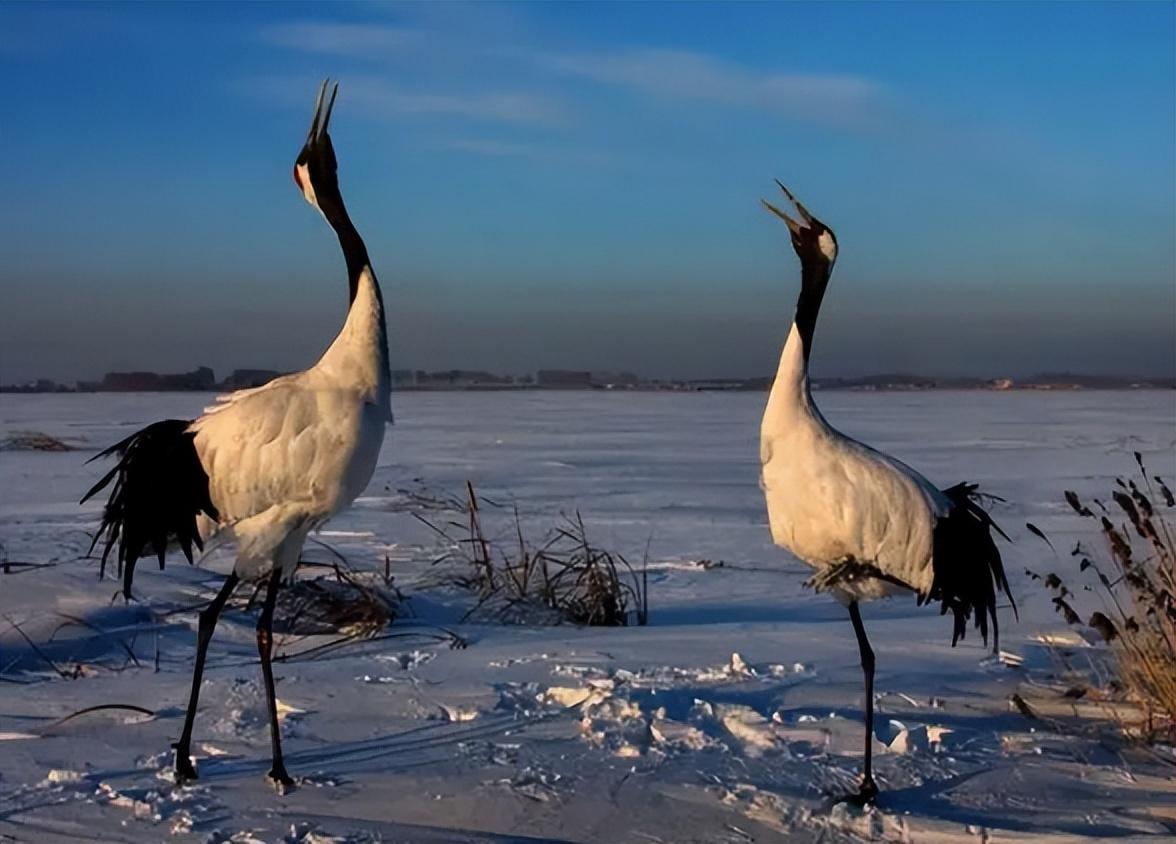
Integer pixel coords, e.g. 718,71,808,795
1027,451,1176,739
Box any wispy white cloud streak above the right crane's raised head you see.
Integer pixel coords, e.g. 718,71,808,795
544,49,883,122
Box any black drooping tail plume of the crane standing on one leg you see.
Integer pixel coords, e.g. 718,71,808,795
923,483,1017,652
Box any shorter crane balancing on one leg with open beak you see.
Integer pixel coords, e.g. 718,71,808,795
760,182,1016,804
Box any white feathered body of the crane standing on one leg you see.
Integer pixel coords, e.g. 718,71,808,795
760,324,950,602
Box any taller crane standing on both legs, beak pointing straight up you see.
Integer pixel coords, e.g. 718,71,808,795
82,81,392,792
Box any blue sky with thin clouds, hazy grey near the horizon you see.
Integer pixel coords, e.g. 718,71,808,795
0,2,1176,382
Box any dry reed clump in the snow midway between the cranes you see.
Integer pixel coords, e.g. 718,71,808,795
416,483,649,627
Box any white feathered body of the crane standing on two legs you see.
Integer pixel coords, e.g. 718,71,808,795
188,269,392,578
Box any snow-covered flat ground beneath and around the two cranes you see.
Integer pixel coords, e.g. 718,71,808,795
0,393,1176,844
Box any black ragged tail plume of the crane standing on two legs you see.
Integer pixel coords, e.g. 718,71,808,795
82,420,218,598
